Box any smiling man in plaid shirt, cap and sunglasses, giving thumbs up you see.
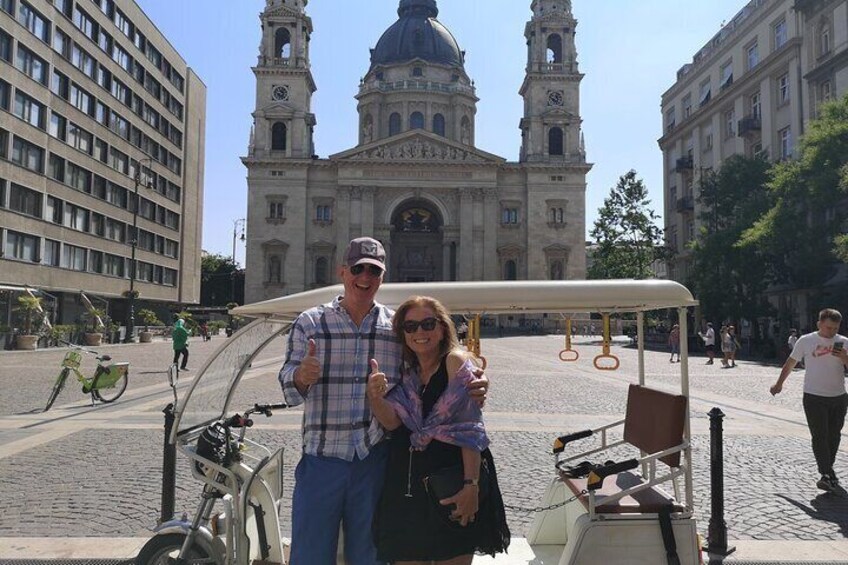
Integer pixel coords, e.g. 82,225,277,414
279,237,488,565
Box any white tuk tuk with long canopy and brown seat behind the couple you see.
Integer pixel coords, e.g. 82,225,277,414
139,280,700,565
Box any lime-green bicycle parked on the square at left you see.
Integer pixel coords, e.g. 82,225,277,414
44,344,130,412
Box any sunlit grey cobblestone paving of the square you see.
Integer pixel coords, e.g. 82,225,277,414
0,336,848,540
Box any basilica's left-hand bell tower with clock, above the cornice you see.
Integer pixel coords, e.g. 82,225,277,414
253,0,317,159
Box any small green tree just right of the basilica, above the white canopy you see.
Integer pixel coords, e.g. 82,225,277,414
587,170,671,279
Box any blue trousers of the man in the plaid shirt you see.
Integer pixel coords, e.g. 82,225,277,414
291,442,388,565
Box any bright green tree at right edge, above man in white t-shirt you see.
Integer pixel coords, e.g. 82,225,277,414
739,95,848,310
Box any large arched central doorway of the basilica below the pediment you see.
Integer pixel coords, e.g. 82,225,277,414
389,199,444,282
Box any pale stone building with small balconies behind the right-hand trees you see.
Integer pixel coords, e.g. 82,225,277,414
659,0,848,323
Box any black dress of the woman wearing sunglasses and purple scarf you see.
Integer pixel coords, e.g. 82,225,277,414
373,360,510,562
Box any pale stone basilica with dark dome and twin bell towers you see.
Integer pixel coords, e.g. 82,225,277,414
242,0,591,303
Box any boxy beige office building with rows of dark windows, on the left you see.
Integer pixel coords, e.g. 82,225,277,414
0,0,206,326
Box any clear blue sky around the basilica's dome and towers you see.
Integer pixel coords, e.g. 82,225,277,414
137,0,745,263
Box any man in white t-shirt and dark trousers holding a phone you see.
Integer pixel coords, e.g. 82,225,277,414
771,308,848,491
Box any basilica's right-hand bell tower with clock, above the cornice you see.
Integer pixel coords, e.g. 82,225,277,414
519,0,586,163
